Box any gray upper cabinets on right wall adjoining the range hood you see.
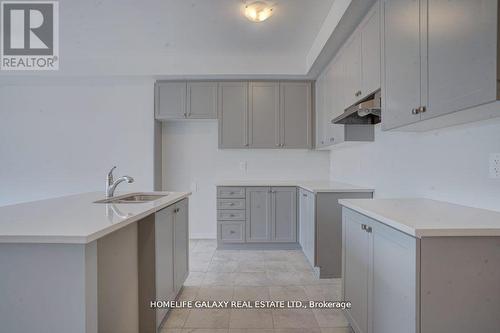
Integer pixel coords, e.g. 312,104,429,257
316,3,380,148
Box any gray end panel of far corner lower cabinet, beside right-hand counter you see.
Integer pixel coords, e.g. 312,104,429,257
316,192,373,279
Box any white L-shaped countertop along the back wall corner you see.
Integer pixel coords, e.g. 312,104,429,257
217,180,374,193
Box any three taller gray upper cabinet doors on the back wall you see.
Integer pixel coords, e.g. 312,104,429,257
218,81,312,149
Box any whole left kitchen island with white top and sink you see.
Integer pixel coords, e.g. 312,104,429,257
0,192,190,333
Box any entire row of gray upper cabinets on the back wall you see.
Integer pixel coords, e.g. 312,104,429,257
155,81,312,149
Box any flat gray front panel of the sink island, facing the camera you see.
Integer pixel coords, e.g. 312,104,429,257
0,244,86,333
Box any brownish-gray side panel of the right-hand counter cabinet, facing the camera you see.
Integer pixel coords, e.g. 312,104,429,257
420,237,500,333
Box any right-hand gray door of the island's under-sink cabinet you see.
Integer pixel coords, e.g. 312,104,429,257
174,199,189,292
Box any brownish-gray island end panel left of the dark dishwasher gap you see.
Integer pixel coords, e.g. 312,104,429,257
97,223,139,333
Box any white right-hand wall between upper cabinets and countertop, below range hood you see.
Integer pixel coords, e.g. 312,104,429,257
330,118,500,211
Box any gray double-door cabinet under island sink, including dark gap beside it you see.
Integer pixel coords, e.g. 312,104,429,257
138,199,189,333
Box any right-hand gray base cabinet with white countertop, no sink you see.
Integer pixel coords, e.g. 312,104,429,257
339,198,500,333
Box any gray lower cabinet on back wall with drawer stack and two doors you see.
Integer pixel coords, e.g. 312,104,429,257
217,186,297,248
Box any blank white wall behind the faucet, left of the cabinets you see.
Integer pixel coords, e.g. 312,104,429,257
0,78,154,205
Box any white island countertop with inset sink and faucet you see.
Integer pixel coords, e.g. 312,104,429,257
0,192,191,244
